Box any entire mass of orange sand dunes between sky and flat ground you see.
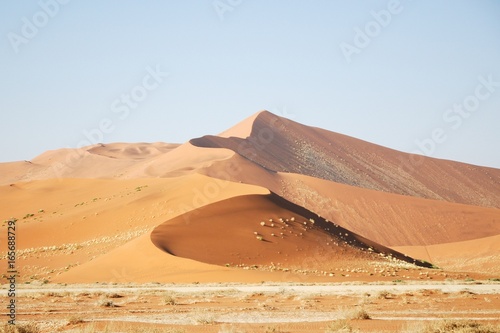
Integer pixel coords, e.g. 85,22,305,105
0,111,500,282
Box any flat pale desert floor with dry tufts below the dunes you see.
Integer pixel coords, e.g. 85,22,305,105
2,279,500,333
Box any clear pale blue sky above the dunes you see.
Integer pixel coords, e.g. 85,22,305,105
0,0,500,168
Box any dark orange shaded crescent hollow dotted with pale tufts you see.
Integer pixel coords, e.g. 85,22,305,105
151,193,428,271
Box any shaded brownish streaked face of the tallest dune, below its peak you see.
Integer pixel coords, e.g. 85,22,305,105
190,111,500,208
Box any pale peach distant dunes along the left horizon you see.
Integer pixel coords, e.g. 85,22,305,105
0,143,234,185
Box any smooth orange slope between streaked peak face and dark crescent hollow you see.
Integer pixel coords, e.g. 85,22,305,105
192,155,500,246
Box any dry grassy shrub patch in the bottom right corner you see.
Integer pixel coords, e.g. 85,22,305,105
407,320,500,333
